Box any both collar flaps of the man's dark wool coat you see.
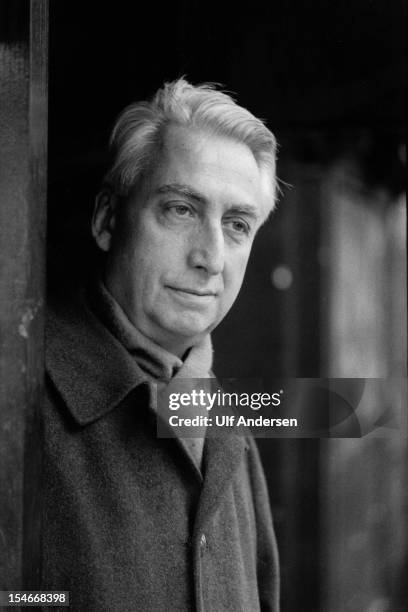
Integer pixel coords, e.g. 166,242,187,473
45,295,249,498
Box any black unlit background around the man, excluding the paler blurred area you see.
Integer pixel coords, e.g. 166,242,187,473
48,0,405,612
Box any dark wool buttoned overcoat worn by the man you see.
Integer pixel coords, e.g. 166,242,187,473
42,294,278,612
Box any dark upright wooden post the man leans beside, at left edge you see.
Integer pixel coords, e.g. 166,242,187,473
0,0,48,590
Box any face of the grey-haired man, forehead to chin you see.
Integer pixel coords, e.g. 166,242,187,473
105,126,265,355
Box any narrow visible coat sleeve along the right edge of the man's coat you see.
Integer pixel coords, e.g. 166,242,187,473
248,439,280,612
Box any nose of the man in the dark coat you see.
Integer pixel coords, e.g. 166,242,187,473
189,223,225,275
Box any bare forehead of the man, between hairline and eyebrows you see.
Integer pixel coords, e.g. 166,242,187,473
151,126,263,213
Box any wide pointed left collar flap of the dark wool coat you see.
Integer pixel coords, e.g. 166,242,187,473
45,295,147,425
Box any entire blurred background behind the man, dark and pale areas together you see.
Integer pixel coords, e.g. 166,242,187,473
48,0,408,612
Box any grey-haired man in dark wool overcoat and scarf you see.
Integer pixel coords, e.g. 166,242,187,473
43,79,278,612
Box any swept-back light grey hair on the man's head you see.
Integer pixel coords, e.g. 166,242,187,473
104,78,278,212
